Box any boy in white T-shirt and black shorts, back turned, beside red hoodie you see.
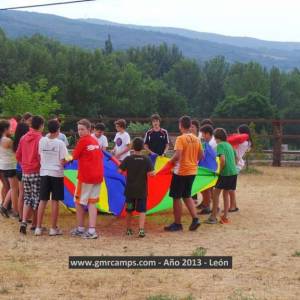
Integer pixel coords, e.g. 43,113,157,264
34,120,68,236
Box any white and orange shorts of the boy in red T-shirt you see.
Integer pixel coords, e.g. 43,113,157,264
74,181,101,205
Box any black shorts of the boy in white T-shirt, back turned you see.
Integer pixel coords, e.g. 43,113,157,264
40,176,64,201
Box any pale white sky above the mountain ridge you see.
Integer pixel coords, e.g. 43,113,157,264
0,0,300,42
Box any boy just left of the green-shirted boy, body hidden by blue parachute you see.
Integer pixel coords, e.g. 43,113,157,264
197,124,217,215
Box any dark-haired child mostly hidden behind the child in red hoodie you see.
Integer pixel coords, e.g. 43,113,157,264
13,122,29,222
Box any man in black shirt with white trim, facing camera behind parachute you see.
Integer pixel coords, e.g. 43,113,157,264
144,114,169,155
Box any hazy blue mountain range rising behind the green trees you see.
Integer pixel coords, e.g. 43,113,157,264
0,11,300,70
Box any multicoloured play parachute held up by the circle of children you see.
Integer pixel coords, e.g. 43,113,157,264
64,144,218,216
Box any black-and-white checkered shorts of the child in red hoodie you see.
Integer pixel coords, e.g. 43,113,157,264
22,173,41,210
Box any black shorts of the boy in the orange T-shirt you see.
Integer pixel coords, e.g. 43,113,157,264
169,174,195,199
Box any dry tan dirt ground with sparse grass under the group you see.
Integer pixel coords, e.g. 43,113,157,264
0,167,300,300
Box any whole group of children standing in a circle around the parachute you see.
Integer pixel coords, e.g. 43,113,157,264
0,113,251,239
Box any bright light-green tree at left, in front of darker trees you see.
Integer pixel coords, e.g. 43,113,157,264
0,79,60,117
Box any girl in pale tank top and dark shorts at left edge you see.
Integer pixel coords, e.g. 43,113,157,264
0,120,19,219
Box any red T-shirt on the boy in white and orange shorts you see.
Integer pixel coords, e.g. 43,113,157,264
73,135,103,184
